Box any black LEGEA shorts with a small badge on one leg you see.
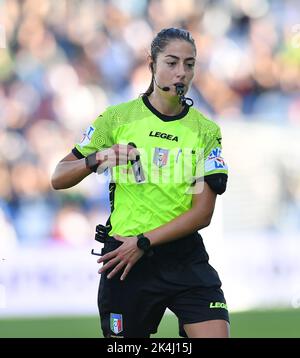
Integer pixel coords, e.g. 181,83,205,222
98,234,229,338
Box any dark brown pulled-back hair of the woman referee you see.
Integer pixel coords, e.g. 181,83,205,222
144,27,196,96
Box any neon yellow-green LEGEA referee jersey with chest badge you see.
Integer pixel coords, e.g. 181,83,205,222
73,96,227,236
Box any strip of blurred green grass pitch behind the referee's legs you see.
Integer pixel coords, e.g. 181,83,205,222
0,309,300,338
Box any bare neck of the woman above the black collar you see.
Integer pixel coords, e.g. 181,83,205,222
148,88,183,116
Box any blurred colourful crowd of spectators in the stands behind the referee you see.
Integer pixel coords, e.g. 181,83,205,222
0,0,300,244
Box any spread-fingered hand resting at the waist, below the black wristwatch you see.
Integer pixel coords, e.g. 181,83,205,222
97,235,144,281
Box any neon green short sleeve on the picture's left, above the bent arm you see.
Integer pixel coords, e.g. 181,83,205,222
72,111,114,157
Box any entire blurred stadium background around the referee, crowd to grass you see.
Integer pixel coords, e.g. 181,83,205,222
0,0,300,337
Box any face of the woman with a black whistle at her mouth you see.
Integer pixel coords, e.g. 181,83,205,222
155,39,196,96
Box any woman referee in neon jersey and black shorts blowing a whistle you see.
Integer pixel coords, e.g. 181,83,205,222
52,28,229,338
